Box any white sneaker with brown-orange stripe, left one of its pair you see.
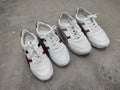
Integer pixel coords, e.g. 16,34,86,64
58,12,91,55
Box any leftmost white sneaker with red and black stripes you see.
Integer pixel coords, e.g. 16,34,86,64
21,29,53,81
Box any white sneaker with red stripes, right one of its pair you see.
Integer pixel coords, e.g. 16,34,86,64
36,22,70,66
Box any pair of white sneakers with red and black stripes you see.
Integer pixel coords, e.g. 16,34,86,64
21,22,70,81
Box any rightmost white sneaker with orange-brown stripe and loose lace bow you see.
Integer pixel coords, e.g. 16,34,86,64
75,9,110,48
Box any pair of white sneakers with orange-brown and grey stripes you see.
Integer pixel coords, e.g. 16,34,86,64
58,8,110,55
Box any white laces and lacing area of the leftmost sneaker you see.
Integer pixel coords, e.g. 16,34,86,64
27,42,44,64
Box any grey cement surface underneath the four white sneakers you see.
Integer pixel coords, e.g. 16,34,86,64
0,0,120,90
